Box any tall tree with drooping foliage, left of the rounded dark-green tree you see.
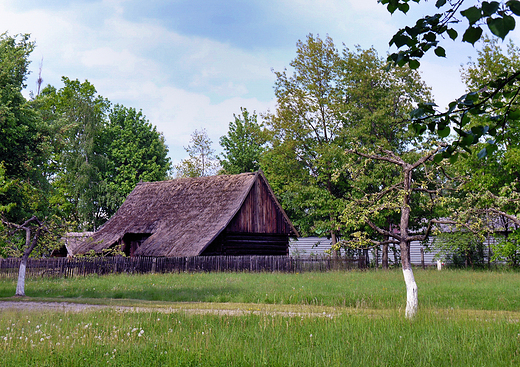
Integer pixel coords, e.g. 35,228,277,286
38,77,110,230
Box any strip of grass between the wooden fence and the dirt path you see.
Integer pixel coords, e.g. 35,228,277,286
0,269,520,311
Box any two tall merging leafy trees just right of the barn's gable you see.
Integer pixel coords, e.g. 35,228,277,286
262,35,431,250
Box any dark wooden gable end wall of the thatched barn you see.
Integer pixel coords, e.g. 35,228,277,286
201,174,296,255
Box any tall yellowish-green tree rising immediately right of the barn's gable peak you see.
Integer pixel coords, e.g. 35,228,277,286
261,34,345,242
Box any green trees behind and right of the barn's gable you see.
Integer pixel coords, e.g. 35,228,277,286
181,35,520,266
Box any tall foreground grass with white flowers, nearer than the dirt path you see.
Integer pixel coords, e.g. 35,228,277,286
0,310,520,367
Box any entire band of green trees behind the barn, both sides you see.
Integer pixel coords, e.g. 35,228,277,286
0,30,520,266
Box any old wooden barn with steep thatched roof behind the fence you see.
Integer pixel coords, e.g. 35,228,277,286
71,172,298,257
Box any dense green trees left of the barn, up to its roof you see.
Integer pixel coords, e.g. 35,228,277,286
0,34,171,256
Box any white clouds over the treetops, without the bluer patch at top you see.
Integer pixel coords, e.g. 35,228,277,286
0,0,472,164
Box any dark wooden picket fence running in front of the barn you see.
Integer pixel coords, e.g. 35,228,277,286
0,256,365,278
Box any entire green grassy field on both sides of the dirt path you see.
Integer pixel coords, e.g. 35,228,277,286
0,270,520,366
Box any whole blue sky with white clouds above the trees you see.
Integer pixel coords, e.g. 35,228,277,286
0,0,520,164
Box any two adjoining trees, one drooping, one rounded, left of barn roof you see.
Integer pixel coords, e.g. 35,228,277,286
32,77,171,230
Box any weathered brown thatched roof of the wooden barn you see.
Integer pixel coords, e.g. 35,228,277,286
76,172,297,257
